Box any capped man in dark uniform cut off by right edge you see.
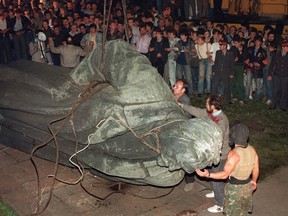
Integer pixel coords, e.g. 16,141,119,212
268,40,288,112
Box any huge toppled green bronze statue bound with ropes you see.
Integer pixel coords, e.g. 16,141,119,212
0,40,222,186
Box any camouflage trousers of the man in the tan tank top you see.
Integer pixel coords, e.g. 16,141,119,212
224,182,253,216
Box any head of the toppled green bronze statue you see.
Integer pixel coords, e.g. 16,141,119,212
157,118,222,173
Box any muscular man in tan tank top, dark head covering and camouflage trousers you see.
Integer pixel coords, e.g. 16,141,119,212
196,123,259,215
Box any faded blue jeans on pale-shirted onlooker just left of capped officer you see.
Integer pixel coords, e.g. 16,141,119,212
198,58,212,94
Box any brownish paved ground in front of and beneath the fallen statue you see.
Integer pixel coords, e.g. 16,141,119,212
0,144,288,216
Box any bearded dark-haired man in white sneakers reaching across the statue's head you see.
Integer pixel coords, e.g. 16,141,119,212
178,95,231,213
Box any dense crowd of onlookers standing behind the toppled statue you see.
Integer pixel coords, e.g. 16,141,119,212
0,0,288,110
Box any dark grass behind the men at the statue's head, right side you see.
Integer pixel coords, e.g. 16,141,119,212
192,98,288,181
